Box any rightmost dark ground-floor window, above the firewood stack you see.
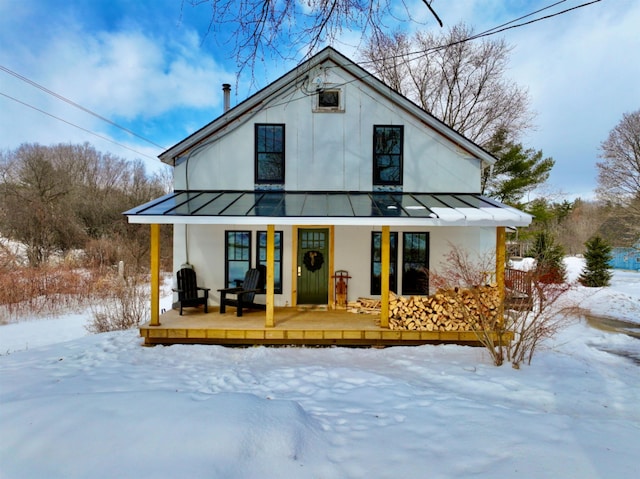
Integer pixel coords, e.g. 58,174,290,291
402,233,429,295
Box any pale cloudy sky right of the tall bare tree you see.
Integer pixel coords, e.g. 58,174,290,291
396,0,640,197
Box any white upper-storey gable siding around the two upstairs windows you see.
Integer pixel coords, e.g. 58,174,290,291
175,59,480,193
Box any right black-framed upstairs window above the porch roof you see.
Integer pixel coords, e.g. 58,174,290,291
373,125,404,185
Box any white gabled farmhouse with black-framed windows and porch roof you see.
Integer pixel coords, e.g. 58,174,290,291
125,48,532,344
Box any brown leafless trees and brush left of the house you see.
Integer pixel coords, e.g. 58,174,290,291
0,143,171,272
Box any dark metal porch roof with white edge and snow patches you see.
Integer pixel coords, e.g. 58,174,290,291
124,190,532,227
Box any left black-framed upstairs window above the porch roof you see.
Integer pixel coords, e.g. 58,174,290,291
255,123,284,184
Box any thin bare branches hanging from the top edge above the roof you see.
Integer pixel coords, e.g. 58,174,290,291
182,0,440,79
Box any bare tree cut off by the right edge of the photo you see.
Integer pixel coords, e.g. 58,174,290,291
597,110,640,243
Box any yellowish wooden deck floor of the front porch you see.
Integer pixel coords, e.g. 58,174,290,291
140,307,490,346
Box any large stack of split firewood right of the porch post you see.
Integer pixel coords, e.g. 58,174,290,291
389,286,500,331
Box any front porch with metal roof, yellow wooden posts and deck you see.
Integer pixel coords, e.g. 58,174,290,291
125,190,531,346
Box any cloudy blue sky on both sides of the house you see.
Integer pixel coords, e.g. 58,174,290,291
0,0,640,199
